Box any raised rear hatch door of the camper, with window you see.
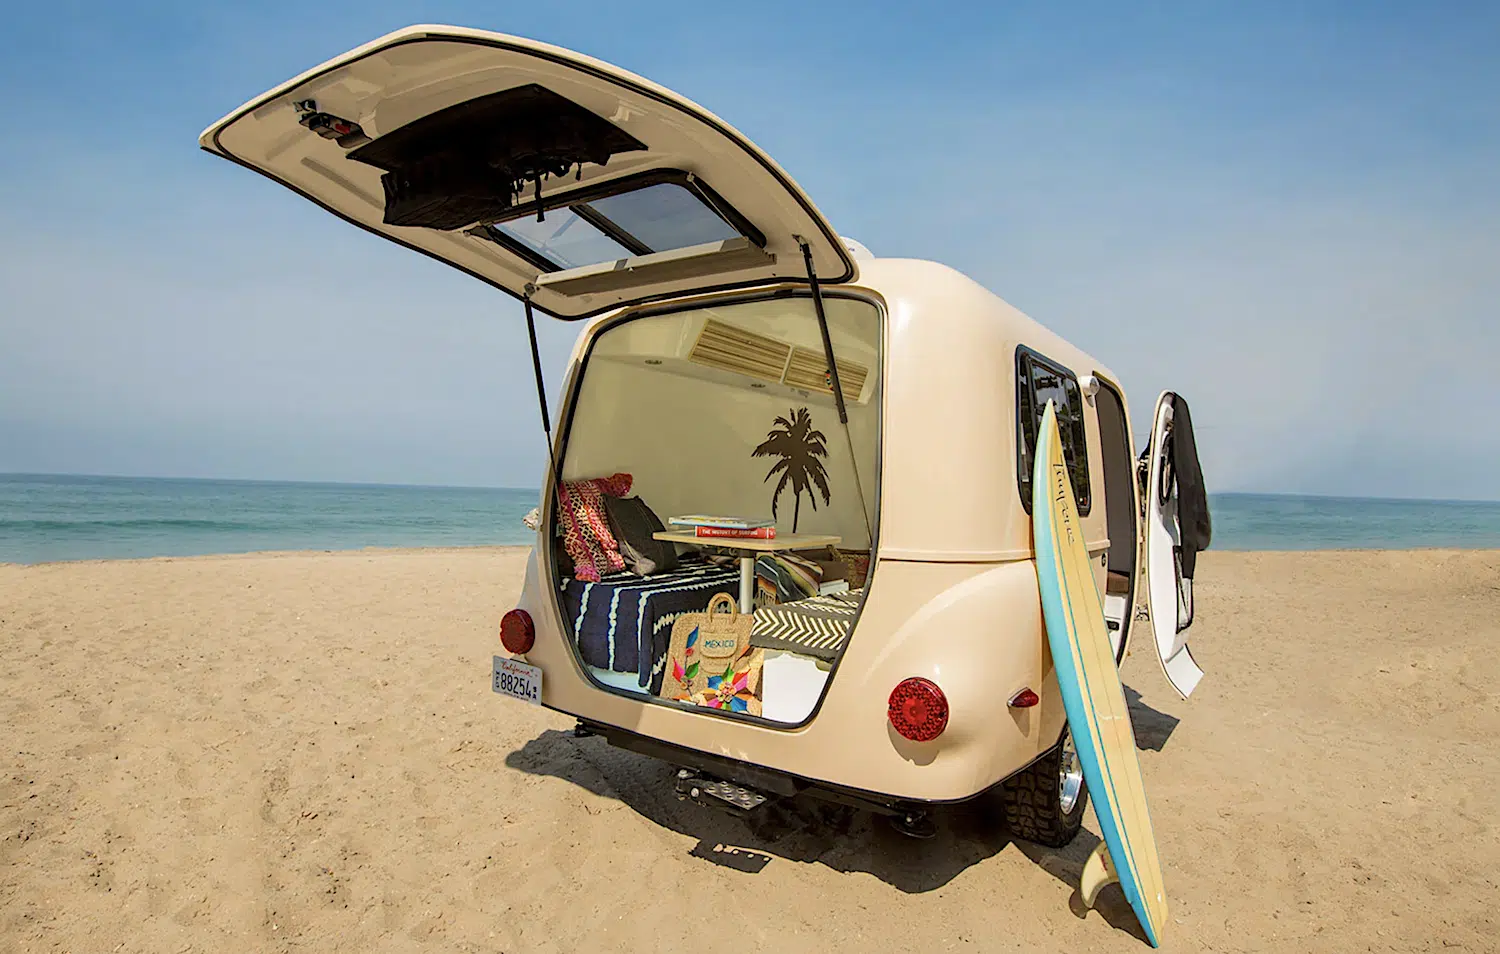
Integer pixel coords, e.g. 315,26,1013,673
200,27,857,318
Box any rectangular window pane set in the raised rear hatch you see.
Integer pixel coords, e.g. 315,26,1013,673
491,182,741,269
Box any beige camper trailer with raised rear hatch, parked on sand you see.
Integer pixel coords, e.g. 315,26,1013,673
201,27,1202,845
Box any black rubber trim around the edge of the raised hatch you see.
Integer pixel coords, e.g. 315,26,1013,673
203,33,855,321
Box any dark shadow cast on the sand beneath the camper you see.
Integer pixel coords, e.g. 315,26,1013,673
506,687,1178,933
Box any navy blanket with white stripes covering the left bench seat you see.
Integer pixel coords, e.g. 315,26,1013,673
563,564,740,693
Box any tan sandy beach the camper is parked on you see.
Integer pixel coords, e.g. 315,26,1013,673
0,549,1500,953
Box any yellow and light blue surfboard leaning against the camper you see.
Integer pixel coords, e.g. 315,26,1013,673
1032,401,1167,947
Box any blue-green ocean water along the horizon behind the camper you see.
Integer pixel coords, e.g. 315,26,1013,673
0,474,1500,564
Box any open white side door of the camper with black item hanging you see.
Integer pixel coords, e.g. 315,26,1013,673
1137,392,1211,699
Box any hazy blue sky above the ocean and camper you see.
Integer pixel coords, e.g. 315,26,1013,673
0,2,1500,500
